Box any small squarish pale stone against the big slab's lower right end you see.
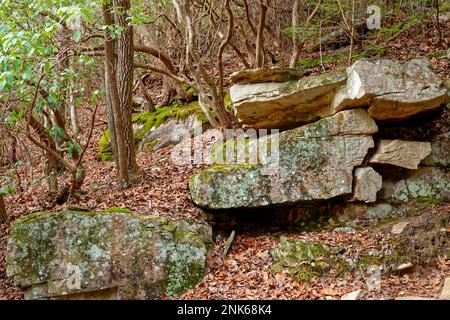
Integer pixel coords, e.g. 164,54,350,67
352,168,383,203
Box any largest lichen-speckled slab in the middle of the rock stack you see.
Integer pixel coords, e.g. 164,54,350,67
189,110,377,209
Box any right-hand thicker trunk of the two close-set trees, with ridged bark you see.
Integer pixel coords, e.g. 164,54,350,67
114,0,139,174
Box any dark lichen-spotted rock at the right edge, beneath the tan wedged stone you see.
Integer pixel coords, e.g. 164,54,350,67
380,167,450,202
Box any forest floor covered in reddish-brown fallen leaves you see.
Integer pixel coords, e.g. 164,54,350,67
0,17,450,300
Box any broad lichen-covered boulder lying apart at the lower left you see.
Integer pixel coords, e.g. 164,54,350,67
6,211,212,299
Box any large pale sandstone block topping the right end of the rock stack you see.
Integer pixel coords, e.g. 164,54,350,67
333,59,448,120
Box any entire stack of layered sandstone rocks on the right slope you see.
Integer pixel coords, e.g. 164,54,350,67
189,60,450,209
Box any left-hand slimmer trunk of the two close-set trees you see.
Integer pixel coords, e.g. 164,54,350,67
102,4,129,188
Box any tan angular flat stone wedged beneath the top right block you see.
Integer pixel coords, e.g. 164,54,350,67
369,140,431,169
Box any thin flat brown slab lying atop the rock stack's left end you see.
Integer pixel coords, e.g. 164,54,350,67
230,67,303,84
